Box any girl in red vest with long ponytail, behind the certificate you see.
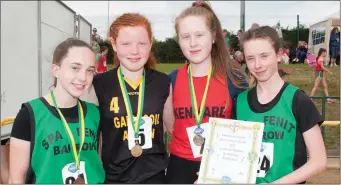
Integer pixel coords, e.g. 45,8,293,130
164,1,248,184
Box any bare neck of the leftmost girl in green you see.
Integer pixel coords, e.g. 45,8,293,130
50,85,78,108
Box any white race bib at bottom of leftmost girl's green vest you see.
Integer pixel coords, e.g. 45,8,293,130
62,161,88,184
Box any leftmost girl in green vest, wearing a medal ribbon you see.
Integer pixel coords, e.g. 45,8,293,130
9,39,104,184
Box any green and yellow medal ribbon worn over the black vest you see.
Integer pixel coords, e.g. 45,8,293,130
117,67,146,138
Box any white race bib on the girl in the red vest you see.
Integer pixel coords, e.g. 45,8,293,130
186,123,210,158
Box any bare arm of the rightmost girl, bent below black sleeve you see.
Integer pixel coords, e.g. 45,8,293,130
272,124,327,184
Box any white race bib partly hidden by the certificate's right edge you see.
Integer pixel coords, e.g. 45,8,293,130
257,142,274,177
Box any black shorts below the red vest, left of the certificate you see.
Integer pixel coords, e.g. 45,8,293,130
166,154,201,184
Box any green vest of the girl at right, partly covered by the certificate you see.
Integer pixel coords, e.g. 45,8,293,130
237,84,298,184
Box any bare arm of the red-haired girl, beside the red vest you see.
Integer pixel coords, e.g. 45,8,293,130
163,84,175,133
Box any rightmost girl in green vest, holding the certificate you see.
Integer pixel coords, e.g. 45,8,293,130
236,26,327,184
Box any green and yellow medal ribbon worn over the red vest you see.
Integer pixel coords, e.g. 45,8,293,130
187,65,212,128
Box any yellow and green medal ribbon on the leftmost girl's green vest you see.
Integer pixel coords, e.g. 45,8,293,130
49,91,85,170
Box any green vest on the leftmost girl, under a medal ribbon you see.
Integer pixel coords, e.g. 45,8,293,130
28,99,105,184
